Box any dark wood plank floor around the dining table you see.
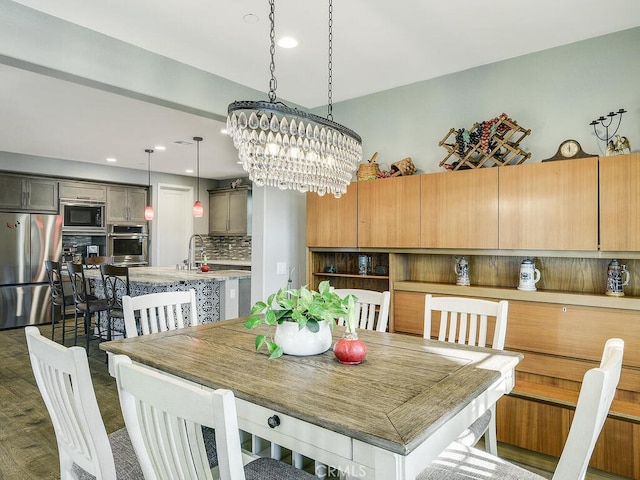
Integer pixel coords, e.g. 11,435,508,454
0,318,628,480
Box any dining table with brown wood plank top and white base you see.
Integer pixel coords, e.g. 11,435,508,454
100,318,522,480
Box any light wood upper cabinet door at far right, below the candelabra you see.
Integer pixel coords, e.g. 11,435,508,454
600,153,640,252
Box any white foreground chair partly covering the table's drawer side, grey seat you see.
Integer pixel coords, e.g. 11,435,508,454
114,355,315,480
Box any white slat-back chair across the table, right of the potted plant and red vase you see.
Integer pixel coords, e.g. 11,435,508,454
423,294,509,455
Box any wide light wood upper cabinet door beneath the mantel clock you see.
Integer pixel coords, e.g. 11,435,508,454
498,157,598,250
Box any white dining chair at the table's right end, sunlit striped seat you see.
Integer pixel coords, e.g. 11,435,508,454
417,338,624,480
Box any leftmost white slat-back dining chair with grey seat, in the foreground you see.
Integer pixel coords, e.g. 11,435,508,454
25,327,143,480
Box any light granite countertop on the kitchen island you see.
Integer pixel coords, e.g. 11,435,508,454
85,267,251,284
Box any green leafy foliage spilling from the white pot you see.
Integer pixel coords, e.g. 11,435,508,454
244,281,355,359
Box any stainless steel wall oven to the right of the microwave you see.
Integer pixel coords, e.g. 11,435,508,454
107,225,149,266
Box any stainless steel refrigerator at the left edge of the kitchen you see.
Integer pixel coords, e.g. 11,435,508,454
0,213,62,330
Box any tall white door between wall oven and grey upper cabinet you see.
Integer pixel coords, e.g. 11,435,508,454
151,183,193,267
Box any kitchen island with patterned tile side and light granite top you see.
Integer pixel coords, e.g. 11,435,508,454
85,267,251,337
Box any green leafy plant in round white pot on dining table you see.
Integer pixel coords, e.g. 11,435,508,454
244,281,353,359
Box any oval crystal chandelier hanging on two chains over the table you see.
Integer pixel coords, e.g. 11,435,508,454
227,0,362,198
